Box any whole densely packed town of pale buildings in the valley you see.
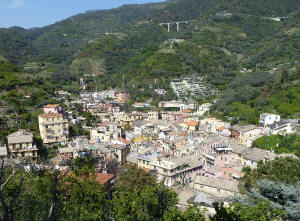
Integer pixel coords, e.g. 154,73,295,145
0,90,299,216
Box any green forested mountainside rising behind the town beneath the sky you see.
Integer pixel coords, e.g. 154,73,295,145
0,0,300,123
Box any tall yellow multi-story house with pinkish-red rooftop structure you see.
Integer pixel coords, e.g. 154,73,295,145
39,106,69,144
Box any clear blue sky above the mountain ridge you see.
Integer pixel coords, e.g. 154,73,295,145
0,0,163,28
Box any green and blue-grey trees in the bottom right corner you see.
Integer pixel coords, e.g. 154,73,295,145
239,158,300,221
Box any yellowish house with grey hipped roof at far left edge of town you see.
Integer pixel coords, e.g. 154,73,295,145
7,130,38,160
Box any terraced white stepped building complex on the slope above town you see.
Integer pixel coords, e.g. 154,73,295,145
171,77,208,98
